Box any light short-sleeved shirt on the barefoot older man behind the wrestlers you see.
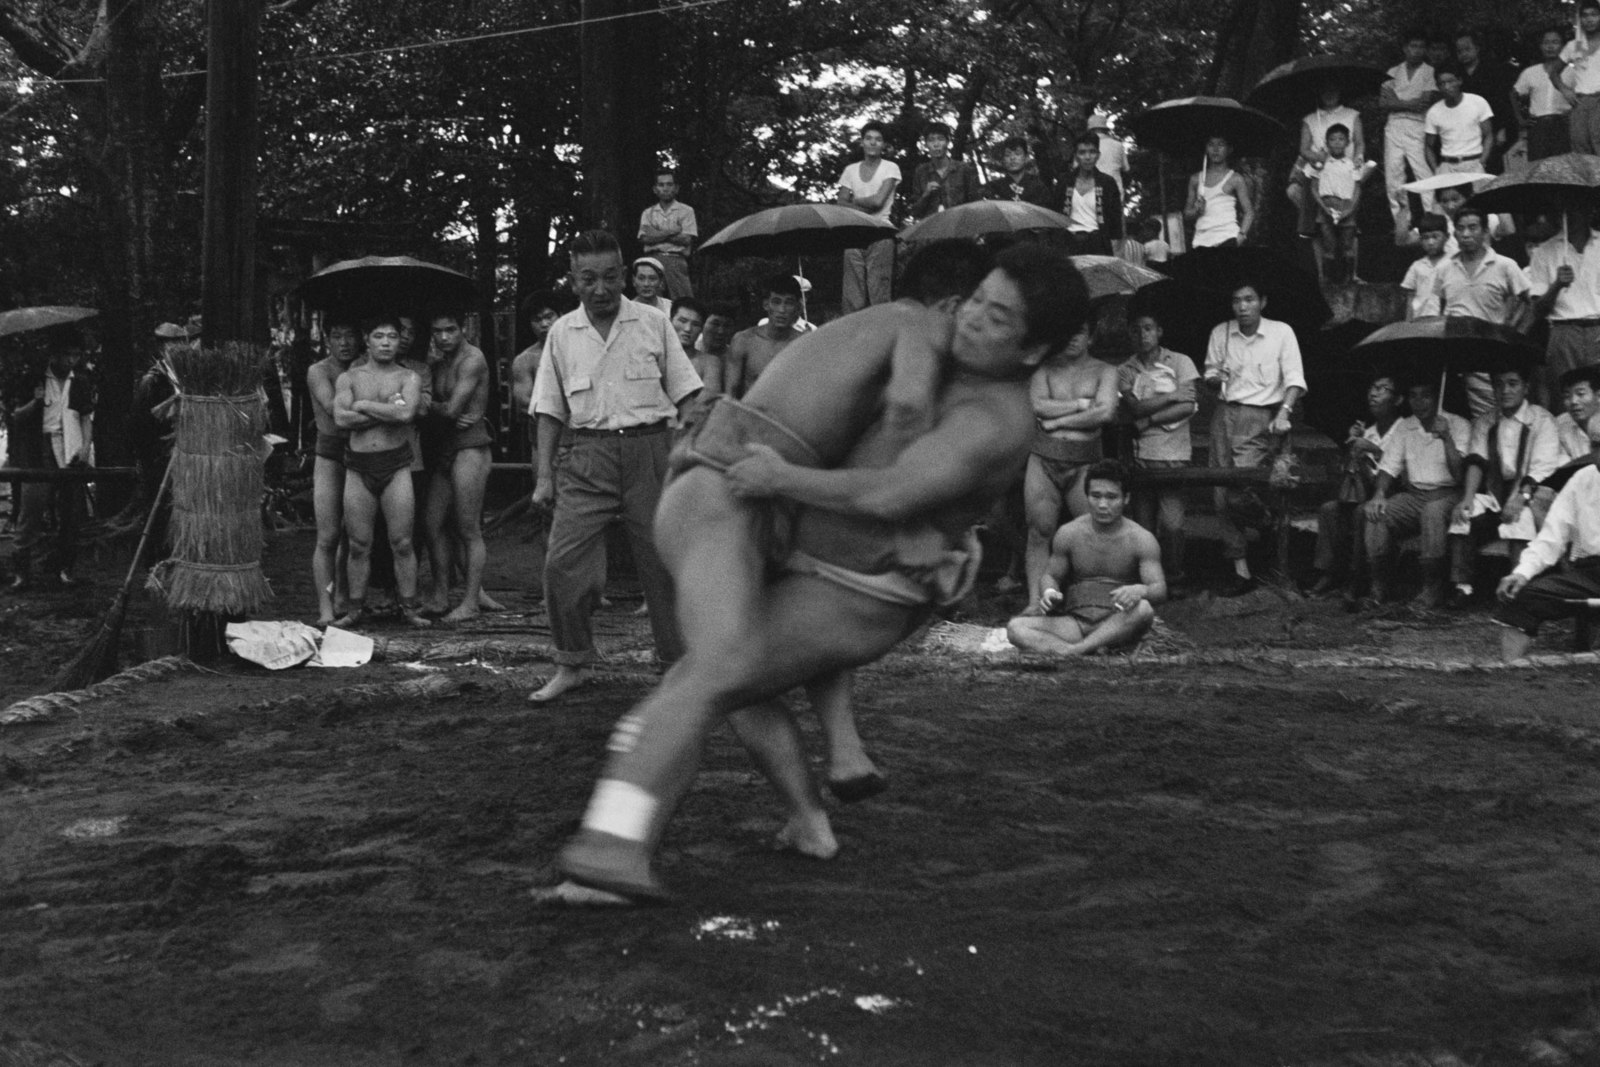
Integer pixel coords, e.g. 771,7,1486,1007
533,296,701,430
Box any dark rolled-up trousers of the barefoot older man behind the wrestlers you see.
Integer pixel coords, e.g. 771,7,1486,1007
544,434,683,667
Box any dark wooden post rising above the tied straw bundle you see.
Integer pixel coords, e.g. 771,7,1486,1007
200,0,262,347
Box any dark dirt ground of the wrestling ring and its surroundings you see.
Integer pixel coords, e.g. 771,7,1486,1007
0,515,1600,1067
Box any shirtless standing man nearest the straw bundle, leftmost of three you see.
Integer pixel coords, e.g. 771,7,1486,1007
306,317,360,625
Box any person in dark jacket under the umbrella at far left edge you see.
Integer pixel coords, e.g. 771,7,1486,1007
11,344,94,592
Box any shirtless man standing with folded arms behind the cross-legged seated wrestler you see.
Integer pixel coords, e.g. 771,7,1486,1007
1022,316,1117,613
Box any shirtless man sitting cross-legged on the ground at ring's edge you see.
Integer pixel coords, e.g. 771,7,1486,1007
1005,459,1166,656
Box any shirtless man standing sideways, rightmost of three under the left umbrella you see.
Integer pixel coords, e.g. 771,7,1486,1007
427,312,502,622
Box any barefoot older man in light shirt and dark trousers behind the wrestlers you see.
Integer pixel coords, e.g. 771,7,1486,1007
528,230,701,704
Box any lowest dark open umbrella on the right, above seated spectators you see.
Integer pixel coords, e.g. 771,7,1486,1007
1350,315,1544,381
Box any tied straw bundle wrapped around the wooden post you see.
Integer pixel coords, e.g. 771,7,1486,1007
150,342,272,616
